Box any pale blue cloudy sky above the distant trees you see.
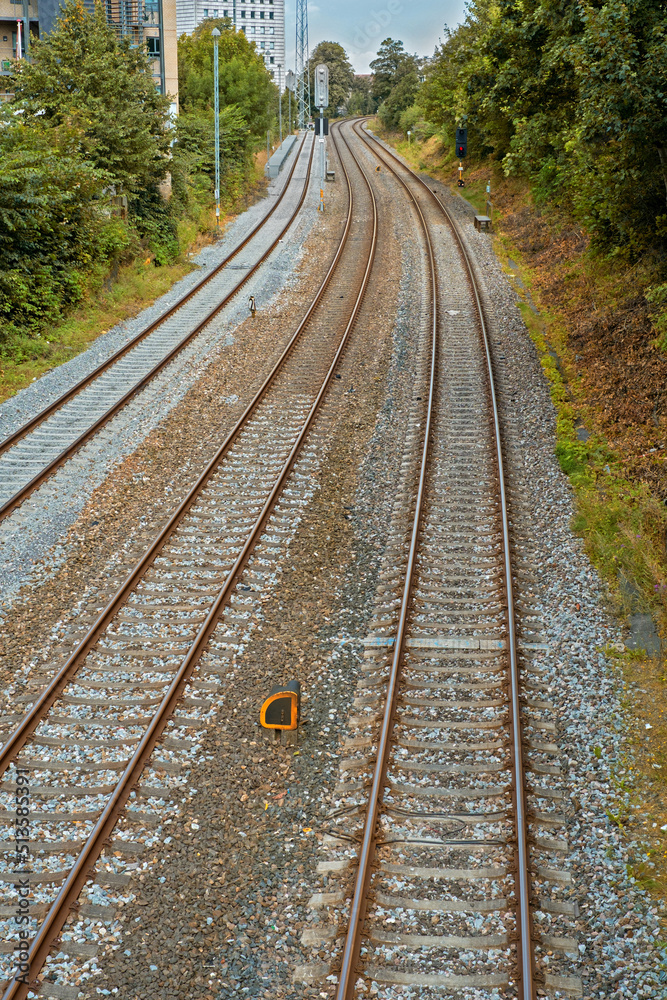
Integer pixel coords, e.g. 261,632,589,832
285,0,464,73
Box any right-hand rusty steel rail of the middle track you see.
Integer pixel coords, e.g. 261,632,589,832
2,121,377,1000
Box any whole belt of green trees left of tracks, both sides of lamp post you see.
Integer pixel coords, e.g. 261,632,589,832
0,0,277,359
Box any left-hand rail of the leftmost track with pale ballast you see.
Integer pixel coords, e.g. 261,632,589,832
0,129,306,455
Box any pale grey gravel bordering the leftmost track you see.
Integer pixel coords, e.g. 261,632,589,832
0,139,319,614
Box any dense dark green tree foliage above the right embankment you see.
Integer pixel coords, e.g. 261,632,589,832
396,0,667,257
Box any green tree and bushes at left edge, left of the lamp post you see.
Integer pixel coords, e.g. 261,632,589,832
0,0,174,351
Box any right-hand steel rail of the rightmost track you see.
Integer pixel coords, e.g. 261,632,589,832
344,119,536,1000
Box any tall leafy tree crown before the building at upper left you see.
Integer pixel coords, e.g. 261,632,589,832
12,0,172,193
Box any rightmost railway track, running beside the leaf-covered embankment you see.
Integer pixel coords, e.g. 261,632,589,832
295,123,581,1000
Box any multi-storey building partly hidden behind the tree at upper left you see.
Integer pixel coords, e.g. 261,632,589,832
0,0,178,114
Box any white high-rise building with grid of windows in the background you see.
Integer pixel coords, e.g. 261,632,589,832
175,0,286,89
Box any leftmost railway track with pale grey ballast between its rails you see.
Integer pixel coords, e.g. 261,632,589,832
0,135,315,520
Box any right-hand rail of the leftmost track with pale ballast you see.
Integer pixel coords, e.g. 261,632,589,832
0,140,315,520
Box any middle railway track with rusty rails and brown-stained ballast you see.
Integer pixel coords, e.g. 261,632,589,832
0,121,377,1000
